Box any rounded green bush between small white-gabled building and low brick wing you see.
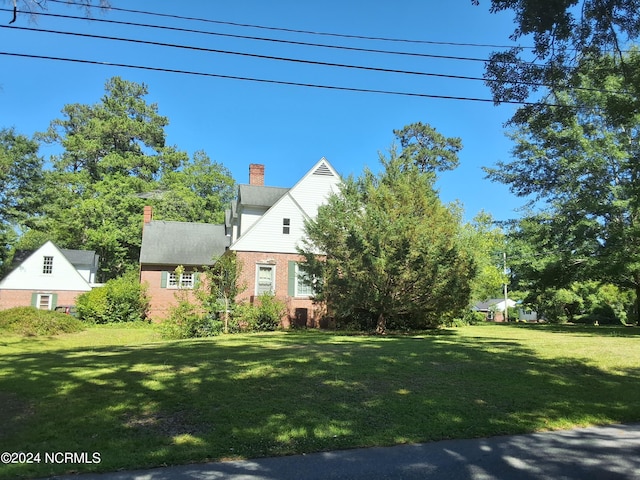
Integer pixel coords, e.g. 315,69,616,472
76,272,149,323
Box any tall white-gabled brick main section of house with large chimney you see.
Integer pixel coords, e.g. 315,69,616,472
226,158,341,326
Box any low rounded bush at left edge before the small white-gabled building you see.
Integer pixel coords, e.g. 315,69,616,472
0,307,84,337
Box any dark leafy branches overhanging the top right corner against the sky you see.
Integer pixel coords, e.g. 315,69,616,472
472,0,640,115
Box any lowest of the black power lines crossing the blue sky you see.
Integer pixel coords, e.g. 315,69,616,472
0,51,559,107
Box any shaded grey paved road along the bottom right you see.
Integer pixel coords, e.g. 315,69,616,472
48,424,640,480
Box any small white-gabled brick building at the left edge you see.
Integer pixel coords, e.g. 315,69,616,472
0,241,99,310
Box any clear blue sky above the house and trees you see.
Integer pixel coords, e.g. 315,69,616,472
0,0,524,220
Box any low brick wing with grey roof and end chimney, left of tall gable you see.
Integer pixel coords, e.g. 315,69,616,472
140,206,229,320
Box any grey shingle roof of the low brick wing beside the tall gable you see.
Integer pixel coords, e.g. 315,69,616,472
140,220,230,266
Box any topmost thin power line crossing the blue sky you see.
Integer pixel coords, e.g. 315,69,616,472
48,0,533,50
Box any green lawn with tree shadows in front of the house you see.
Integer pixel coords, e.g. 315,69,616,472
0,325,640,478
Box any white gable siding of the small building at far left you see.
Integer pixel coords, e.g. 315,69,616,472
0,242,91,291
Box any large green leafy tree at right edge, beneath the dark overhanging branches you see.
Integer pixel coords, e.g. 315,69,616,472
487,50,640,322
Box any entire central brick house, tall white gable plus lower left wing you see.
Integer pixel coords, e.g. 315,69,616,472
140,158,341,326
